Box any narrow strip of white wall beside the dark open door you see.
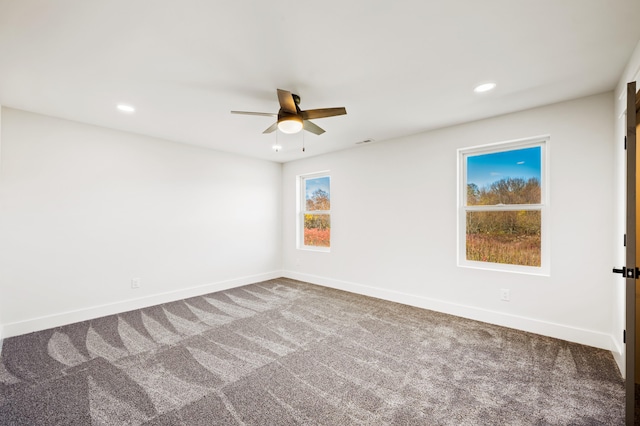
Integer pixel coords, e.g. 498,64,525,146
610,39,640,375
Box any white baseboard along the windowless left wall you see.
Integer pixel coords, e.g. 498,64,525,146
0,271,282,338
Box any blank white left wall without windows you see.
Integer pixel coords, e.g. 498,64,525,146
0,108,281,337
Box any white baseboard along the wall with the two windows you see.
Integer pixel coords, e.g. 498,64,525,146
282,270,618,356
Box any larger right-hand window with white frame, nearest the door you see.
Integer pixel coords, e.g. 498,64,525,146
458,138,549,274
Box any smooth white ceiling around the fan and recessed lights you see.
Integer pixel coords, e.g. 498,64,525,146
0,0,640,162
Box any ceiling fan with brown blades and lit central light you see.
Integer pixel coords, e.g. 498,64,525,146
231,89,347,135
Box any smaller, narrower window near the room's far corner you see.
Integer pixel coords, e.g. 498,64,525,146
298,172,331,251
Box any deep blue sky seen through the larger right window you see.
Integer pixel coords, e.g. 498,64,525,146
467,146,541,188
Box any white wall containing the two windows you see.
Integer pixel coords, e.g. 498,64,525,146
283,93,614,349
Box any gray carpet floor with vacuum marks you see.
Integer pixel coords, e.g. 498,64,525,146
0,279,624,426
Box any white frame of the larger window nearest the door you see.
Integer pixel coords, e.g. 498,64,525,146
457,135,550,276
